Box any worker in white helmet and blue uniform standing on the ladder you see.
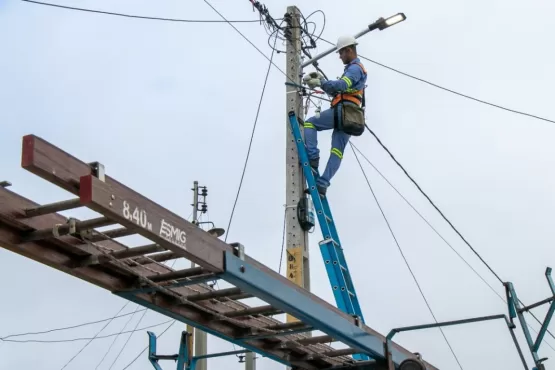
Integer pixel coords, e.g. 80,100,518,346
303,36,366,196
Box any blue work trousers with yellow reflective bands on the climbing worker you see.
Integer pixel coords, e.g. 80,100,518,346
304,103,351,187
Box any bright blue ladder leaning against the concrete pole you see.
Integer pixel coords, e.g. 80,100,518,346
289,112,369,361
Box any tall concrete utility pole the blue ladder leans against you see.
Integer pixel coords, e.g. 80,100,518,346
285,6,310,322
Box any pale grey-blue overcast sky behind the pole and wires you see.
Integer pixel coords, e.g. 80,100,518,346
0,0,555,370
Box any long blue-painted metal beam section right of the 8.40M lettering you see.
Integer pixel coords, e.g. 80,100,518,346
223,252,414,366
